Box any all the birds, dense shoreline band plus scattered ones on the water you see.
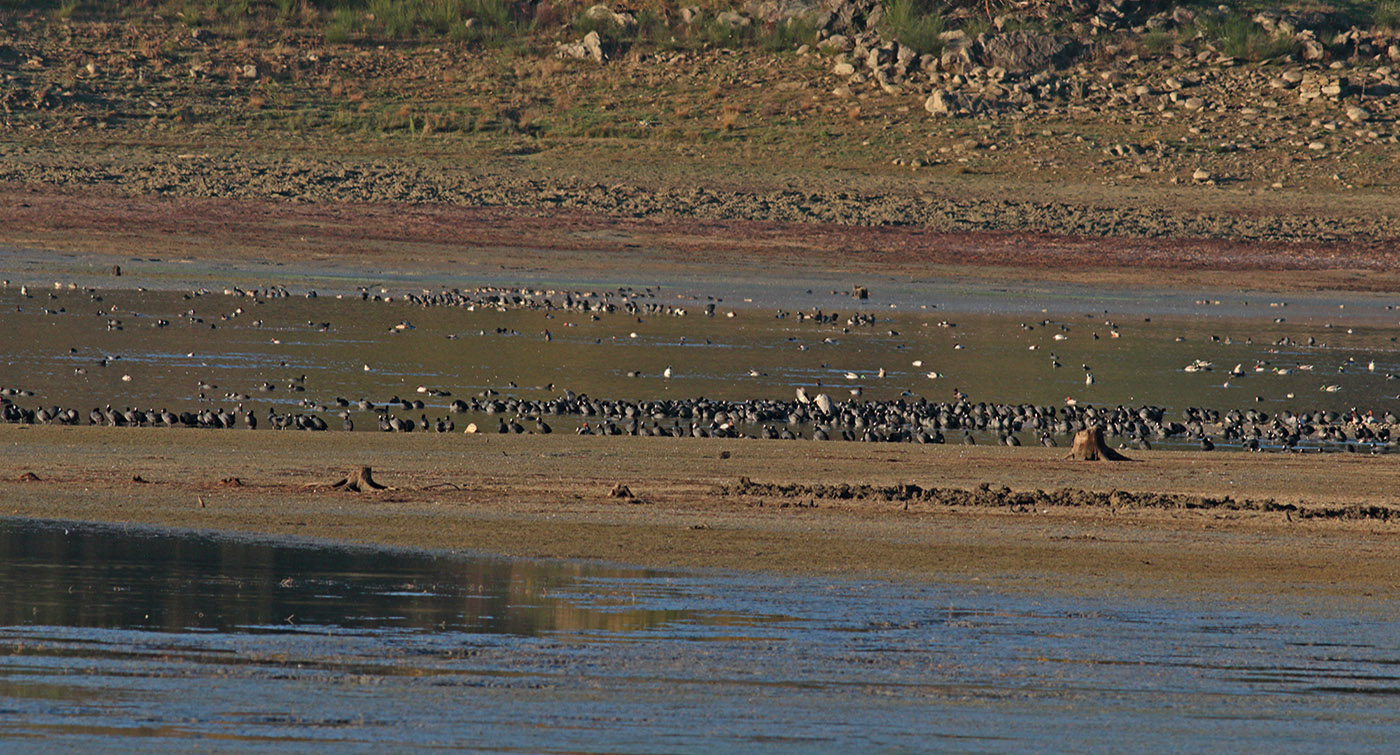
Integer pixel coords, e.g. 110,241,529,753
8,278,1400,452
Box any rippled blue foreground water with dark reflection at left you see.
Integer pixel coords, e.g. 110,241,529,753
0,520,1400,752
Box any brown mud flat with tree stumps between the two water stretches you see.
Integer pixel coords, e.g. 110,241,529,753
0,426,1400,598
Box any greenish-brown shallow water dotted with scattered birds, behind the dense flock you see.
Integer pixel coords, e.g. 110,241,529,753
0,284,1400,442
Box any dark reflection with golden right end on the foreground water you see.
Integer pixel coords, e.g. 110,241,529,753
0,520,692,636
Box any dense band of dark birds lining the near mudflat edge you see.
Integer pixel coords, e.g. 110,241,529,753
0,389,1400,454
